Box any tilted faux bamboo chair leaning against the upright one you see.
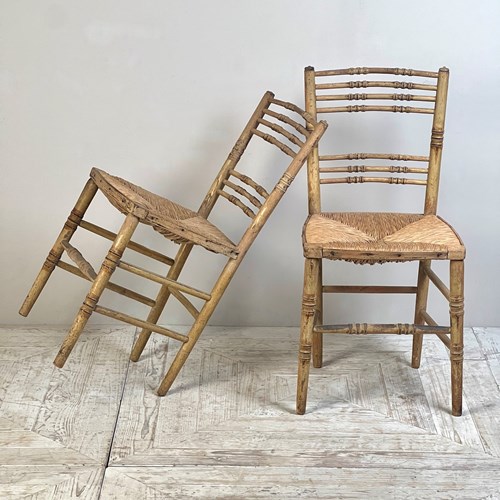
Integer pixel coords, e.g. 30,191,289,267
19,92,326,396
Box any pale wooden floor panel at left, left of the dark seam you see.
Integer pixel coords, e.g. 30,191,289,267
0,327,134,465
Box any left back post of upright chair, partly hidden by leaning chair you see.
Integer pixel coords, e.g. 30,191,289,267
304,66,321,215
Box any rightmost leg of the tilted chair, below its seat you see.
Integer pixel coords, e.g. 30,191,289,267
157,252,241,396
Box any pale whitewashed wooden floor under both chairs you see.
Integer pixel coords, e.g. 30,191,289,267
0,327,500,500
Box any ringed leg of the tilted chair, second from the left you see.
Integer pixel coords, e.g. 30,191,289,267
54,214,139,368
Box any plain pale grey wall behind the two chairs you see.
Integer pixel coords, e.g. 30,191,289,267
0,0,500,326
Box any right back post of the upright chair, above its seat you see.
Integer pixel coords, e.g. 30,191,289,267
424,67,449,215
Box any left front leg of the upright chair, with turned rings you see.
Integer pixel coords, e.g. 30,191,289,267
296,259,320,415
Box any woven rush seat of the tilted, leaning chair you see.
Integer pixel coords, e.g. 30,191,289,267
90,168,238,258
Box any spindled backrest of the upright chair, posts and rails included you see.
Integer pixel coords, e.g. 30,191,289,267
305,66,449,214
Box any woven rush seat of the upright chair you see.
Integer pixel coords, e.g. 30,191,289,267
303,212,465,264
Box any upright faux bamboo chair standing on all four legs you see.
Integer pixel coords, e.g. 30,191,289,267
297,67,465,416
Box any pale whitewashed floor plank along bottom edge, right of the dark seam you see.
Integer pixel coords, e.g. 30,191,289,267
101,466,498,500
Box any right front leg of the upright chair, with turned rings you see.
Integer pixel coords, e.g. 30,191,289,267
450,260,464,417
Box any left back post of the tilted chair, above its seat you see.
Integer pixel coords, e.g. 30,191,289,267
198,91,274,218
